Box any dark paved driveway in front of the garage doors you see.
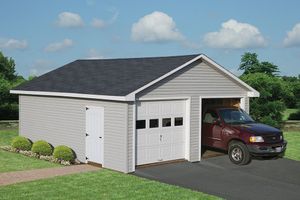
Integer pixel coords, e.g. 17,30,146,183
134,155,300,200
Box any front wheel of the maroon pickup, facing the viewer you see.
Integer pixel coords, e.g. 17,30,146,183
228,141,251,165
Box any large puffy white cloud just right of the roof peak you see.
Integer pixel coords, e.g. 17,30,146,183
203,19,267,49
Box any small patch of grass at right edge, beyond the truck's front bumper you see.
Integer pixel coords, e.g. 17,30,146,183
284,132,300,161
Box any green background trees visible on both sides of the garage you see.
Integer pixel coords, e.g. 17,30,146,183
0,52,300,127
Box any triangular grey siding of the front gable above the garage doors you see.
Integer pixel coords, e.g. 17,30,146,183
138,62,249,98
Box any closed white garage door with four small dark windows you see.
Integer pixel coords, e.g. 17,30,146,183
136,100,186,165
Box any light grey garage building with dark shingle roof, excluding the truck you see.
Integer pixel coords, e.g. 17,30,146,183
11,54,259,173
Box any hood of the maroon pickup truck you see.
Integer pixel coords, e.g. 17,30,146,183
232,123,281,135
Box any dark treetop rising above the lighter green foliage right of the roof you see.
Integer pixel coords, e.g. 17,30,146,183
238,52,279,76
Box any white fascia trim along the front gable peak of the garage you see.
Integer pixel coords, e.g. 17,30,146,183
126,54,259,101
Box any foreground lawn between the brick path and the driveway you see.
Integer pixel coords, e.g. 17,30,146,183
0,169,218,200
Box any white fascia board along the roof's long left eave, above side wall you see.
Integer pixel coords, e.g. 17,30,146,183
10,90,128,101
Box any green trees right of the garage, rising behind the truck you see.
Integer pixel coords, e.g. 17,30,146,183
238,52,300,127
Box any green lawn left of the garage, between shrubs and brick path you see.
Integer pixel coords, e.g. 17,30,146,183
0,129,61,173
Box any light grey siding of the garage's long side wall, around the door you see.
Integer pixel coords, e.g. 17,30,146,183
19,95,128,172
